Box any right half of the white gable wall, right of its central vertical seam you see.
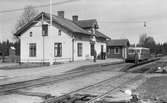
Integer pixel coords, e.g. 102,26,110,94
46,23,72,61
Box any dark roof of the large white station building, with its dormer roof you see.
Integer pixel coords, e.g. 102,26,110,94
15,12,107,38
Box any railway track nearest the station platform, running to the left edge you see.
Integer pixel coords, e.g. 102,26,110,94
0,63,125,95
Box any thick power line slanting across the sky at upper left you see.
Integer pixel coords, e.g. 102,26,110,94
0,0,78,14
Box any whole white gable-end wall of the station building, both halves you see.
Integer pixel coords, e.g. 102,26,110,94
21,23,72,62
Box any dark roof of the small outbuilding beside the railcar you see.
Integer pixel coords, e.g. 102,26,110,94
107,39,130,46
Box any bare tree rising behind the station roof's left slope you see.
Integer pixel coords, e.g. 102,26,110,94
15,6,38,31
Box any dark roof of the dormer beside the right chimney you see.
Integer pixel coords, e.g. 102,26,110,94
75,19,98,28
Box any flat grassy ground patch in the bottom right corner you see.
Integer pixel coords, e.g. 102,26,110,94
136,76,167,101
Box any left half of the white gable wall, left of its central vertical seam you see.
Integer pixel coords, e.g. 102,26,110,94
20,23,43,62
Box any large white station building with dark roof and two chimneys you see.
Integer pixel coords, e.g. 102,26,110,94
15,11,109,63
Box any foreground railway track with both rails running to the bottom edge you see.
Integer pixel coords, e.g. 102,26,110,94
42,72,143,103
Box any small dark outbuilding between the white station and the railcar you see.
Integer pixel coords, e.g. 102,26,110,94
107,39,130,59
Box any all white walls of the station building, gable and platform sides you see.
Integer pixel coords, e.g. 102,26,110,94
21,22,106,62
